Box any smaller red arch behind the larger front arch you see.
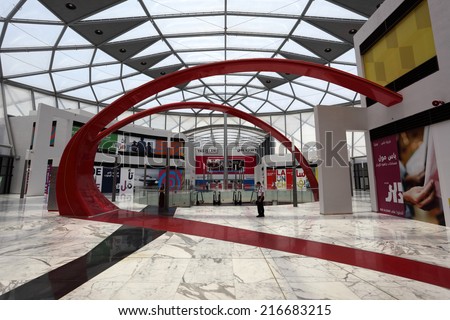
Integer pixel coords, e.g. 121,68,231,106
94,102,319,201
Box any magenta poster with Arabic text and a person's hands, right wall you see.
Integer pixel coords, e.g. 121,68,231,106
372,126,445,225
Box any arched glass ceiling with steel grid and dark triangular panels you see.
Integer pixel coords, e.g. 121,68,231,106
0,0,382,119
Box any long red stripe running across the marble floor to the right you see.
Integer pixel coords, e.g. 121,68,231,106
83,210,450,289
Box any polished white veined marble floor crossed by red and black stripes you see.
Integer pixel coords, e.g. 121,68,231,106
0,194,450,300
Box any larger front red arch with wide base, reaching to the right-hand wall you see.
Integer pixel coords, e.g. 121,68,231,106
56,58,402,217
